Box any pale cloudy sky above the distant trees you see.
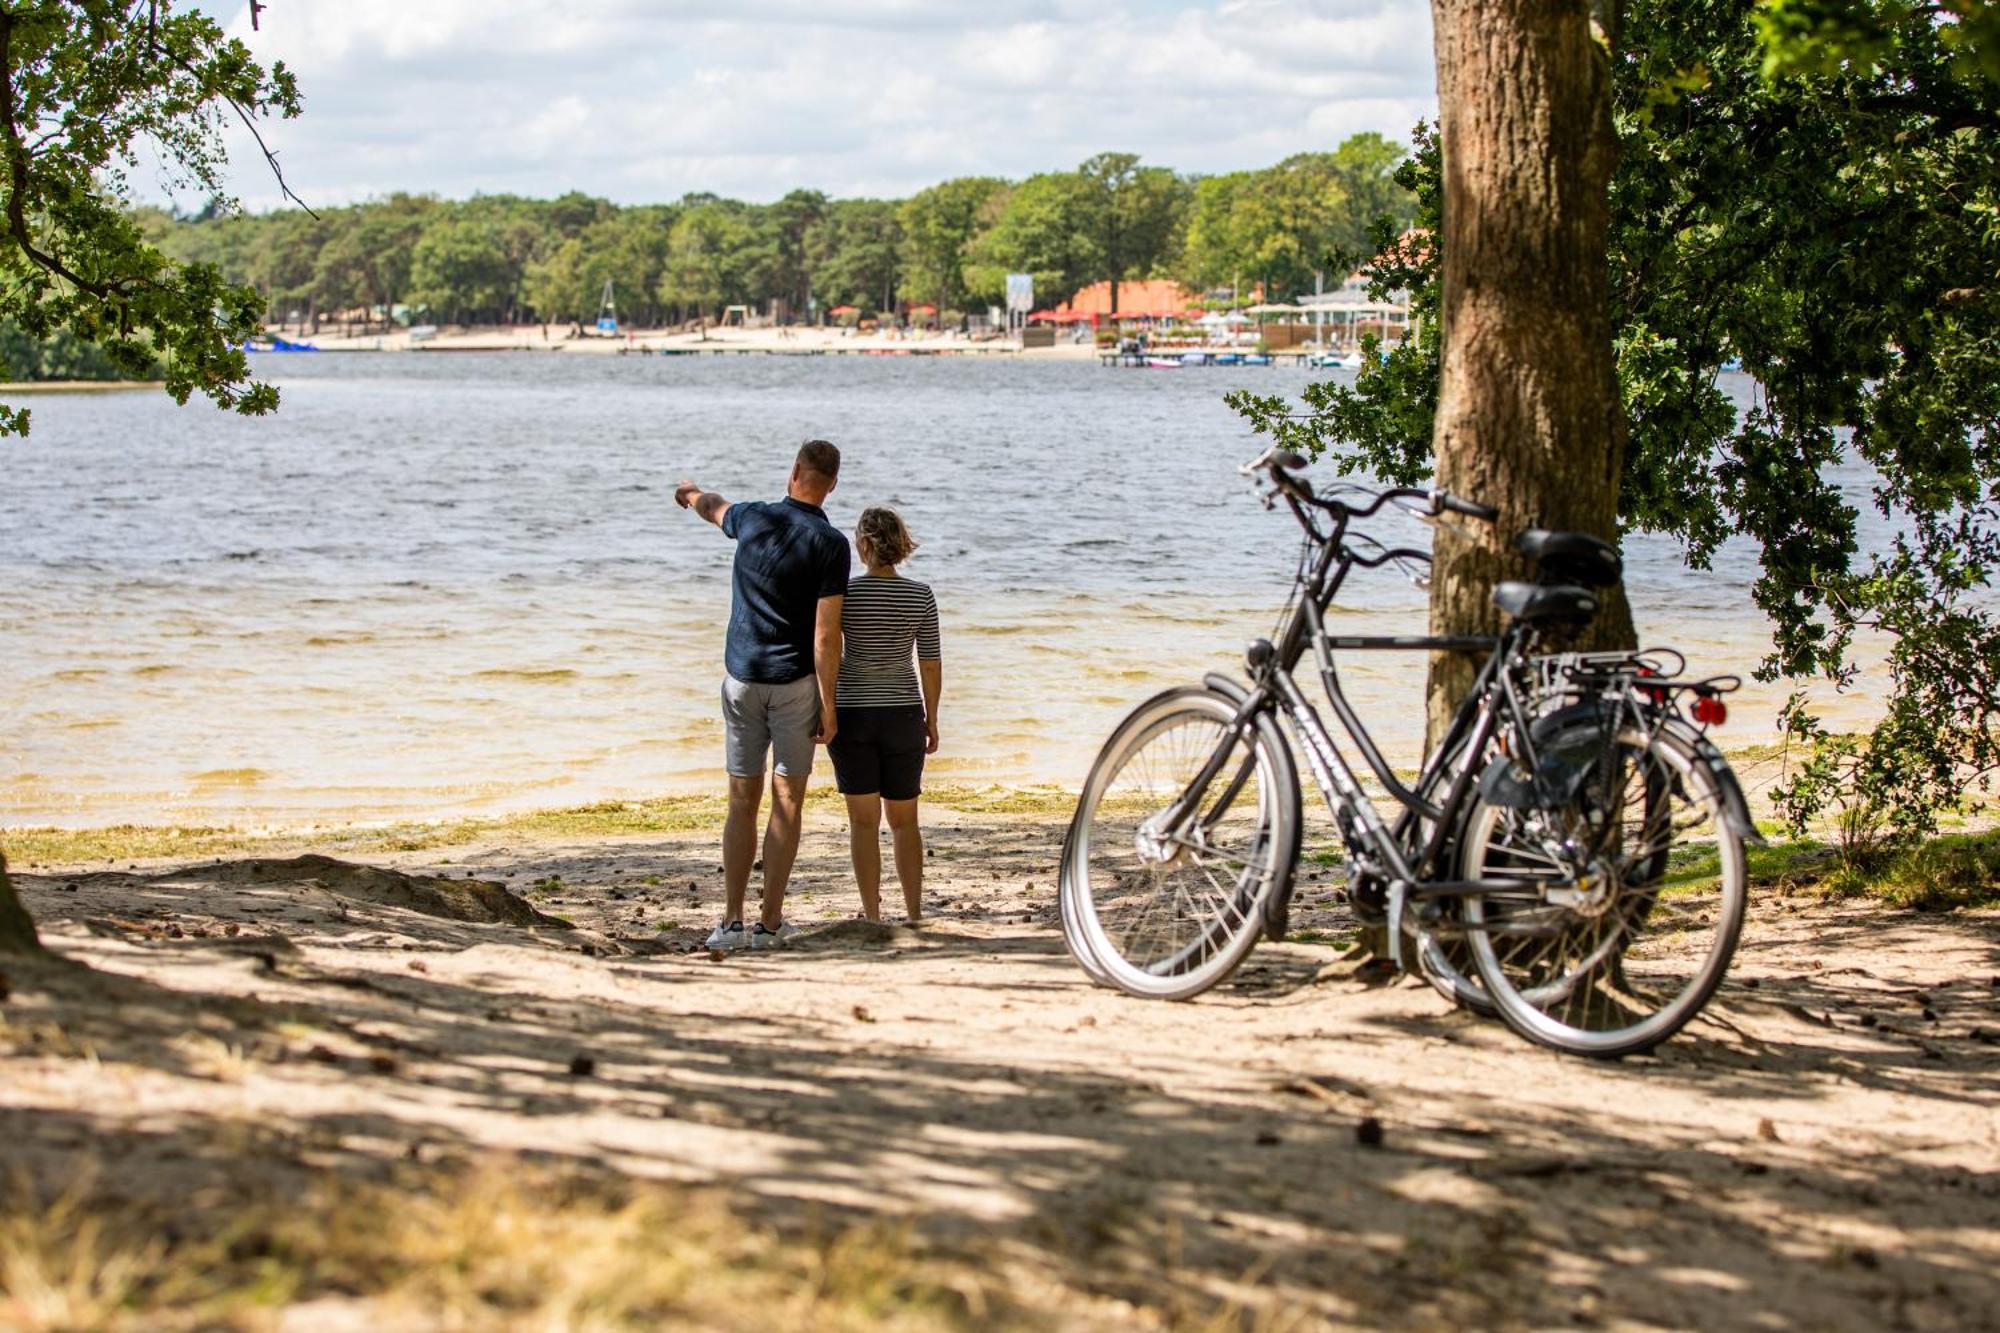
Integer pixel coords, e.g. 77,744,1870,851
164,0,1436,210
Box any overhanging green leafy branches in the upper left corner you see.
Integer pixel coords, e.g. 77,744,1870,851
0,0,298,434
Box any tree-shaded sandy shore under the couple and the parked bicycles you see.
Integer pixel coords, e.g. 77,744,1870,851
0,793,2000,1329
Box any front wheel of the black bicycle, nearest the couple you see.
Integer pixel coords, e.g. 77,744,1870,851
1060,687,1300,999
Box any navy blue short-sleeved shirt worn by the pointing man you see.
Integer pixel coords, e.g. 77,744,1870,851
722,496,850,685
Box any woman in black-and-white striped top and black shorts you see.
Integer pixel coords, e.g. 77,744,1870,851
828,508,944,925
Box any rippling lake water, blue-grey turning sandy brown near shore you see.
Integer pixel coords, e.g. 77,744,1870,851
0,354,1896,825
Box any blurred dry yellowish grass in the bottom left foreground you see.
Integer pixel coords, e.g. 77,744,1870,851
0,1161,1096,1333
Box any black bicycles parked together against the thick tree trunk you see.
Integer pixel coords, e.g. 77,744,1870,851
1060,450,1758,1057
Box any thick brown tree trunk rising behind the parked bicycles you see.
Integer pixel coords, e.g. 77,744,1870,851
1428,0,1632,735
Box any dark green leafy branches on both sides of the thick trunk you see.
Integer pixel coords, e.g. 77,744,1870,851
1234,0,2000,833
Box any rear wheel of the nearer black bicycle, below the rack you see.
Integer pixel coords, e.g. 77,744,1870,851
1464,723,1748,1057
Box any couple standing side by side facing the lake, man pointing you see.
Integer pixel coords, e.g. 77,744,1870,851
674,440,944,949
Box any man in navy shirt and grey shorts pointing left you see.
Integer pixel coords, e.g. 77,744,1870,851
674,440,848,949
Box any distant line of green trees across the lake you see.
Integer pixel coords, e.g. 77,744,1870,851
140,134,1412,326
